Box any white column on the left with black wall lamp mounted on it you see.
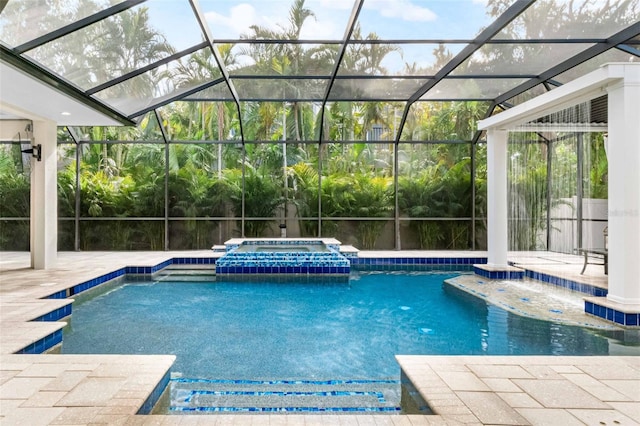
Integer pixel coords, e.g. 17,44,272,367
30,121,58,269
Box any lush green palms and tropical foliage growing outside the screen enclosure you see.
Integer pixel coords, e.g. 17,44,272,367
0,0,620,253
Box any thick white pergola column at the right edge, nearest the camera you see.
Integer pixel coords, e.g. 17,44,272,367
607,66,640,304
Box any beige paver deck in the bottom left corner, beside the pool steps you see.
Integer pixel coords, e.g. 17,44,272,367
0,355,175,425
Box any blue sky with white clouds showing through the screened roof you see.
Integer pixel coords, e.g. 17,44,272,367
140,0,491,74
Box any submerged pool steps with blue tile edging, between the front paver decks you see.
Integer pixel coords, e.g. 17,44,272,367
170,378,400,414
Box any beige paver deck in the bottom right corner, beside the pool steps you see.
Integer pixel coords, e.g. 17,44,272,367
396,355,640,425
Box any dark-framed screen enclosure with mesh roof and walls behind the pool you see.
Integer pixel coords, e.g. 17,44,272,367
0,0,640,266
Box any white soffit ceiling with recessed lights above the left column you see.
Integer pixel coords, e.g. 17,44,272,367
0,61,127,126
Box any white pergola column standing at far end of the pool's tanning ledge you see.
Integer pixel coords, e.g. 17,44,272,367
487,129,509,267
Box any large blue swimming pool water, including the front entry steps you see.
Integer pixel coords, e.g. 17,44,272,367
62,271,634,411
